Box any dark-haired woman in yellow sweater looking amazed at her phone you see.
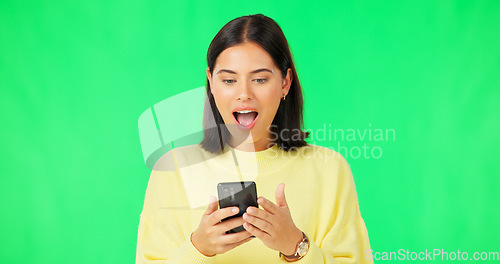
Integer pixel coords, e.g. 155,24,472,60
136,14,372,263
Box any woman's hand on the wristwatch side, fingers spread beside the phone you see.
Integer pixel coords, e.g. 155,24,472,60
243,183,302,255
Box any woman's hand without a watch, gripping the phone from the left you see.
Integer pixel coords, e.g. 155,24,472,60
191,196,253,257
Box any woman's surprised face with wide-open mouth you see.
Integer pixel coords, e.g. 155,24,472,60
207,42,292,151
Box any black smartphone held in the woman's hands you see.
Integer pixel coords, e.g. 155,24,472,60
217,181,259,234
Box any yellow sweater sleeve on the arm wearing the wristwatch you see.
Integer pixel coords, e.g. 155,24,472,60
286,156,373,264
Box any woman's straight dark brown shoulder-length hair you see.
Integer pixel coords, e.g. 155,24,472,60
201,14,309,153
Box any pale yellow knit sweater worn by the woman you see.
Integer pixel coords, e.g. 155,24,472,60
136,145,373,264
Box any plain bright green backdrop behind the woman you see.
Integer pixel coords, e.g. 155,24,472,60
0,0,500,263
